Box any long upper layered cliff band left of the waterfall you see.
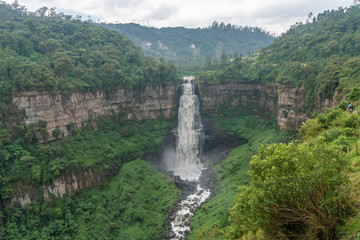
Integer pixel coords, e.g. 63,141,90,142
13,84,177,140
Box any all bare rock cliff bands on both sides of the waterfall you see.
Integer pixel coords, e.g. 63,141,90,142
10,83,340,206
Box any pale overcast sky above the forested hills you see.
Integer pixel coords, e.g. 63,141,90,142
5,0,353,35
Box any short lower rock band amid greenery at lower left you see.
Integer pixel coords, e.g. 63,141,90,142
10,169,111,207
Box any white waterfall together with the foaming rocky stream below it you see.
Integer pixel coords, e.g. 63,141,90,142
167,77,210,239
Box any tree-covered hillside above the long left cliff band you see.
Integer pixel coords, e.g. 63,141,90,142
0,1,179,137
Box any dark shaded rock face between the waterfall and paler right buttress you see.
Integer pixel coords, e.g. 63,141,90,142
199,83,277,115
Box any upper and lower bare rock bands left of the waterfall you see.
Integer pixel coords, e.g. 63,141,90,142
9,84,178,206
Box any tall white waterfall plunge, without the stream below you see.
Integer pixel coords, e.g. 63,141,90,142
174,77,203,180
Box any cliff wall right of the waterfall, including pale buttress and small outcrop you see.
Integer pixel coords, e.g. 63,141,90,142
198,83,342,129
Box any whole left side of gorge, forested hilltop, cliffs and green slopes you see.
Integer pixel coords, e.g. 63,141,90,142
0,2,180,239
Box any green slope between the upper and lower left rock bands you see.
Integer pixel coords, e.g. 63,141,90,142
0,117,171,194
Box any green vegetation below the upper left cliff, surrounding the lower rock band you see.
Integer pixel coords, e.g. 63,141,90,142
0,111,178,239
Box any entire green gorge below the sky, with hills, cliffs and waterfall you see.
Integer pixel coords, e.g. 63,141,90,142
0,2,360,240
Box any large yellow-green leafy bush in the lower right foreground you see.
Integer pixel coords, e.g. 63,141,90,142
229,142,351,239
